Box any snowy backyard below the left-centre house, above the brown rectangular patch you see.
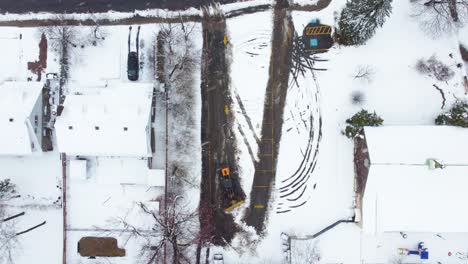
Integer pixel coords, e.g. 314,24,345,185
67,158,163,230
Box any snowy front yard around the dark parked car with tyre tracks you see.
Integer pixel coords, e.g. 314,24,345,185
70,24,159,85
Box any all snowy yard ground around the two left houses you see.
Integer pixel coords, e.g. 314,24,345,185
0,25,169,264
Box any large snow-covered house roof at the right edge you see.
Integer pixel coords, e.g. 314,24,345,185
362,126,468,234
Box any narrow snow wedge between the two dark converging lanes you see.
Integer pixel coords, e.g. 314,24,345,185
226,11,273,216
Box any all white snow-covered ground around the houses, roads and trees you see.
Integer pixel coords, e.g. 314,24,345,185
0,0,468,264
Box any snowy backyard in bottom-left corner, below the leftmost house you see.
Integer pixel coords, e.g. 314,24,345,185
0,153,63,264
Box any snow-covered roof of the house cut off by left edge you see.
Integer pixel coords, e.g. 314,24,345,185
0,82,44,155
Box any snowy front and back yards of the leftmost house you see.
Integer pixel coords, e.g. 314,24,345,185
0,27,63,264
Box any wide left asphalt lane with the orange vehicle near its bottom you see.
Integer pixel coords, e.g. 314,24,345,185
200,11,245,244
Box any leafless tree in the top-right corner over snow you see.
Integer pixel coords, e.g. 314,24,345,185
411,0,468,37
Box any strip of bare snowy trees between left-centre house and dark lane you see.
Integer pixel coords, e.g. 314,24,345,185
158,19,200,194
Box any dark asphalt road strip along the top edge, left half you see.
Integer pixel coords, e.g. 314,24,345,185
0,0,238,13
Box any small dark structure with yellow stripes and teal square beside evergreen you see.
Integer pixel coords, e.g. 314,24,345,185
302,19,333,53
